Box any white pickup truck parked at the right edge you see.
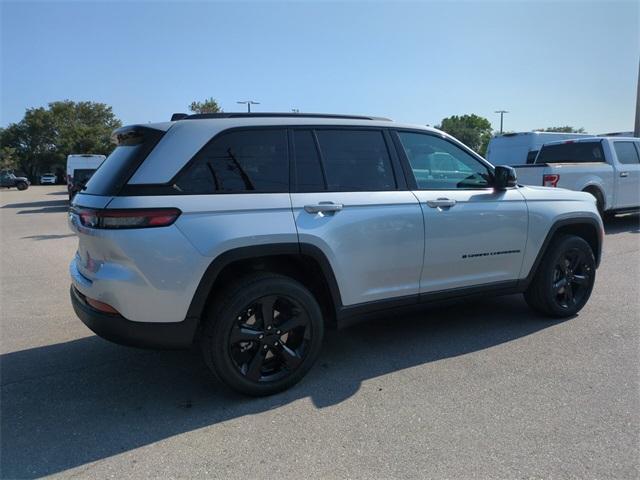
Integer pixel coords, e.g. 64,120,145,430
515,137,640,215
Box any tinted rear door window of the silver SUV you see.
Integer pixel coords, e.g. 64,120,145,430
316,130,396,191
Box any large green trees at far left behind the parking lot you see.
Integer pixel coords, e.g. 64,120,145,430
0,100,122,180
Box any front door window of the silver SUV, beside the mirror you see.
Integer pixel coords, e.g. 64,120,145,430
398,132,490,190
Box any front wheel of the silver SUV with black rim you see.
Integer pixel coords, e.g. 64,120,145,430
524,235,596,318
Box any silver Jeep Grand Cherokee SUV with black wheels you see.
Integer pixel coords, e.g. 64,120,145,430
69,113,603,395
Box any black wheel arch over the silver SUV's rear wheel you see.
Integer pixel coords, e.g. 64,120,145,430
187,243,342,323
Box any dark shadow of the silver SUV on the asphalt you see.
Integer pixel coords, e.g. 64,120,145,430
0,295,557,478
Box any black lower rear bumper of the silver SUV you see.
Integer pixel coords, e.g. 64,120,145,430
70,285,198,349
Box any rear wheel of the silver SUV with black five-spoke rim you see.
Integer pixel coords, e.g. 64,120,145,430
200,273,324,396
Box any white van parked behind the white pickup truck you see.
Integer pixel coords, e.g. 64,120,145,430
486,132,593,166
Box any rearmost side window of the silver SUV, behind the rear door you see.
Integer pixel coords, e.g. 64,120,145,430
176,129,289,194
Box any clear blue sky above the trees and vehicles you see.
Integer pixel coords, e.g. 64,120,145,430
0,0,640,133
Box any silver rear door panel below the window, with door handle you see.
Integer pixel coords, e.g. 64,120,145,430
291,191,424,305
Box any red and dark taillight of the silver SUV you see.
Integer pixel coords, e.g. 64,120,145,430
75,208,182,229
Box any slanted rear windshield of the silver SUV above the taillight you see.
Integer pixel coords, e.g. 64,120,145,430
82,128,164,196
